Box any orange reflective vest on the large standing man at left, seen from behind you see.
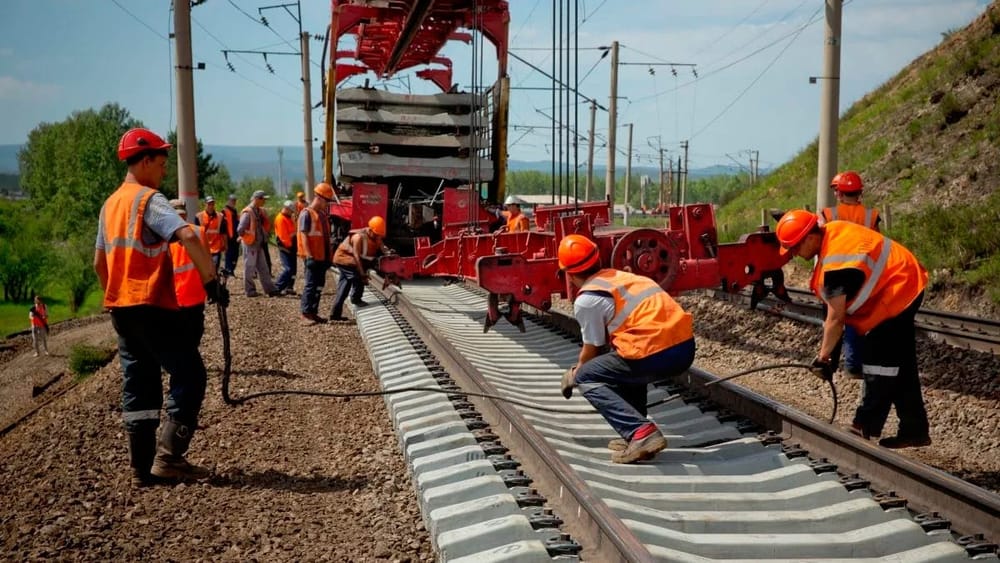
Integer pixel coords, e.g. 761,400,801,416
100,183,177,309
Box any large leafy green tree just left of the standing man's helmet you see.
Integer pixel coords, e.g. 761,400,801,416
18,104,142,240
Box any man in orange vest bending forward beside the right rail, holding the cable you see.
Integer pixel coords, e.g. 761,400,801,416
776,210,931,448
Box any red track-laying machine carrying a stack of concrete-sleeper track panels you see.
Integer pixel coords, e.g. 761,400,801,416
324,0,787,330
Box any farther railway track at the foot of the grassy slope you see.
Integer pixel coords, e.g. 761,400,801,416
705,288,1000,355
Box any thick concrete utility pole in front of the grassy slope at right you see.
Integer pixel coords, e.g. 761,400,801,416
816,0,844,209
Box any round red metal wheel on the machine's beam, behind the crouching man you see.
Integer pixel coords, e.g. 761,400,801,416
611,229,681,290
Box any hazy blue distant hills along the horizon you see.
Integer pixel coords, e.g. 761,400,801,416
0,145,752,184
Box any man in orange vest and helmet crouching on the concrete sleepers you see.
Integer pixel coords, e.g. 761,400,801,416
559,234,695,463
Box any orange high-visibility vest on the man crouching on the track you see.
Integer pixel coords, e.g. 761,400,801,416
580,268,694,360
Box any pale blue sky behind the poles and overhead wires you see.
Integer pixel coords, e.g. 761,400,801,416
0,0,987,171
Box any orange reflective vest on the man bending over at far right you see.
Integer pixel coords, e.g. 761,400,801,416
809,221,927,334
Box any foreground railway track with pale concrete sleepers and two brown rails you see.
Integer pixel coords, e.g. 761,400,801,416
357,280,1000,561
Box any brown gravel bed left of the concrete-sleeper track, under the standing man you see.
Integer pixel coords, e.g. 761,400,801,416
0,276,434,562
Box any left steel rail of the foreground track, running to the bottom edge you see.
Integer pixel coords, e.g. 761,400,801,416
369,276,655,561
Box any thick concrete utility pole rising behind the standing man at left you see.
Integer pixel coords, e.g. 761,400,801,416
174,2,198,222
